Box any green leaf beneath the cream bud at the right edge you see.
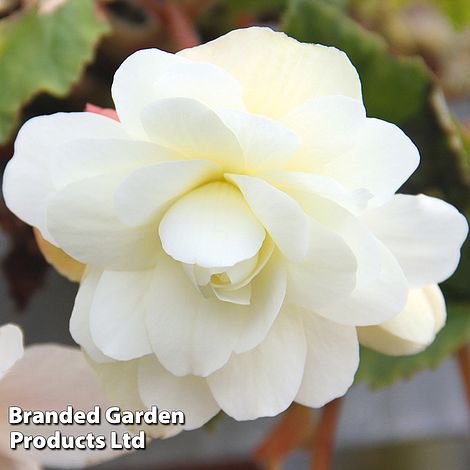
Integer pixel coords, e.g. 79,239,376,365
356,304,470,389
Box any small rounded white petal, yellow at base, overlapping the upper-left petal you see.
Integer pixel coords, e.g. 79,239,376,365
141,98,244,171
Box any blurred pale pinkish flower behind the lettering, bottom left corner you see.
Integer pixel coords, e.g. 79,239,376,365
0,324,127,470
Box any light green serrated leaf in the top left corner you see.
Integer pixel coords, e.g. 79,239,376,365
0,0,108,143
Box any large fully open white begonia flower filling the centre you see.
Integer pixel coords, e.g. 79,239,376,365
3,27,467,422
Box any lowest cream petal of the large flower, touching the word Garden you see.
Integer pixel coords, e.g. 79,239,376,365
138,356,220,430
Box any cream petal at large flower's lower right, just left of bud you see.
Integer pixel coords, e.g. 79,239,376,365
295,310,359,408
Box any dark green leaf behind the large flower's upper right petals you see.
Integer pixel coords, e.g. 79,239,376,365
283,0,430,123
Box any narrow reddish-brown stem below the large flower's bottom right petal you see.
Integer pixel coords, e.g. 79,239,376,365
311,398,341,470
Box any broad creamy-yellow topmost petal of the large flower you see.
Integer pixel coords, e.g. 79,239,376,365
178,27,361,118
